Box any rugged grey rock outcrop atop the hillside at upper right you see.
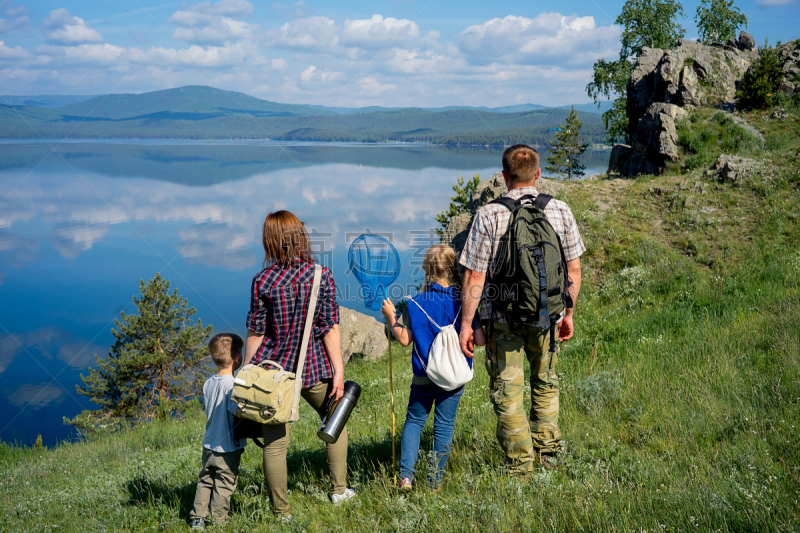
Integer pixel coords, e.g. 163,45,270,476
608,32,800,176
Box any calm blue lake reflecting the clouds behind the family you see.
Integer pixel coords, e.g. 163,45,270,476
0,141,609,445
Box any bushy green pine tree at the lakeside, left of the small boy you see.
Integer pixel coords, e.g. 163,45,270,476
64,274,213,434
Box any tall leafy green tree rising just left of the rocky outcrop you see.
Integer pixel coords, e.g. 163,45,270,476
586,0,685,142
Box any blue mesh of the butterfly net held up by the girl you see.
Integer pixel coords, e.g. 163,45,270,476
347,233,400,311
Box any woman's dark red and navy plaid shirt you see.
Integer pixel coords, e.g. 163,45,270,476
247,260,339,389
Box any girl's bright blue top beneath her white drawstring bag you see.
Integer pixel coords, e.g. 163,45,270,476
399,283,480,376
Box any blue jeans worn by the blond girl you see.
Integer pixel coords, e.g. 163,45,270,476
400,383,464,487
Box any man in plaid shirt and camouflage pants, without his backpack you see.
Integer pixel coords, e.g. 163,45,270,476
459,144,586,474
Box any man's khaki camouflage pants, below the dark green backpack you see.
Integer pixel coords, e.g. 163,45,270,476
486,322,562,473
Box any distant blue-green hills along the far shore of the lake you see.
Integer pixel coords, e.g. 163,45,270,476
0,86,604,145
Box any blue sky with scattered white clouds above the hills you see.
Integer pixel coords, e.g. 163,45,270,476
0,0,800,107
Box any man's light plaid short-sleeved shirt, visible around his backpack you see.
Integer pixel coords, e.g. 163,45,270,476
459,187,586,322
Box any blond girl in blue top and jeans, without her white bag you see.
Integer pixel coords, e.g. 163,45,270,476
382,244,486,492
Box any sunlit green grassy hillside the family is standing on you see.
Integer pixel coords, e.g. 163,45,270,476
0,108,800,533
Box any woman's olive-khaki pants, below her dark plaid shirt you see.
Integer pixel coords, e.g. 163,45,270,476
263,380,347,516
